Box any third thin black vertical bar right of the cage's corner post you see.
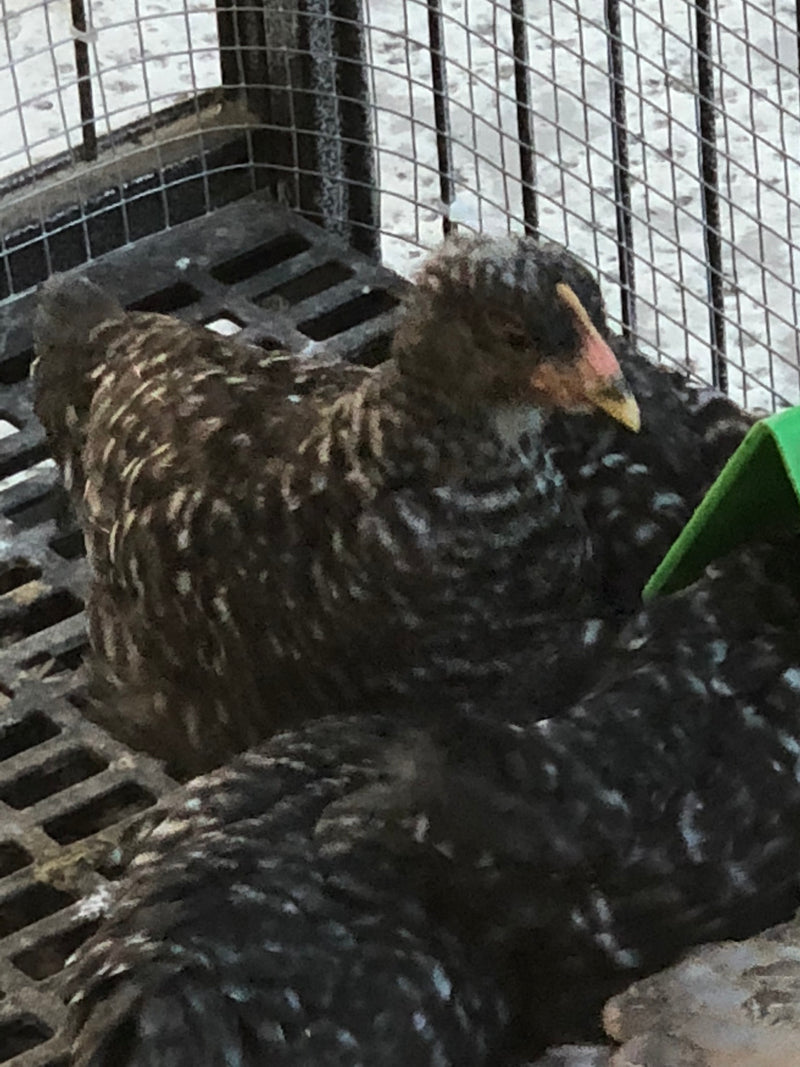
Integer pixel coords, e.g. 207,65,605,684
605,0,636,337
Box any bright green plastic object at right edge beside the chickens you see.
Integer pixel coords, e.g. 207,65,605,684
642,407,800,601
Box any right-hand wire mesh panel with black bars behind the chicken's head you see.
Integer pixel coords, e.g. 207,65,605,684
365,0,800,407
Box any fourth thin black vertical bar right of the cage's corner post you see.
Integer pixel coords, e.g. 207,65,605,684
694,0,727,391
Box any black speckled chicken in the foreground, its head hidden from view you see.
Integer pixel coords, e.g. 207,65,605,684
64,544,800,1067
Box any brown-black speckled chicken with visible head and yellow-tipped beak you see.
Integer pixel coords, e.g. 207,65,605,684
34,237,639,775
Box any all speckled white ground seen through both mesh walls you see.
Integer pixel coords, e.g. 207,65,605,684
0,0,800,407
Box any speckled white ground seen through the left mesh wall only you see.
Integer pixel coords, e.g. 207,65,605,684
0,0,220,176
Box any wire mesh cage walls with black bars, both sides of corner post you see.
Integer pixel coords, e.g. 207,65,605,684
0,0,800,407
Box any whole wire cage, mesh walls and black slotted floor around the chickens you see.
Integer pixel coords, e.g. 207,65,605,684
0,0,800,1067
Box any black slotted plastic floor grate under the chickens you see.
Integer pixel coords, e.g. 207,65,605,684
0,194,405,1067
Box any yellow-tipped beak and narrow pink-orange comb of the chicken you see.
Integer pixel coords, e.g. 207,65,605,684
556,282,641,433
